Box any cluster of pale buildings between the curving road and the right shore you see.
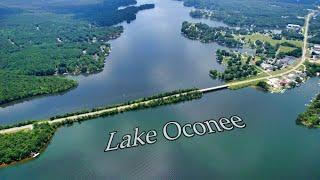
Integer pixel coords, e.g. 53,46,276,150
267,71,307,92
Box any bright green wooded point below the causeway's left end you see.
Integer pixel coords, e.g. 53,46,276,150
0,124,56,165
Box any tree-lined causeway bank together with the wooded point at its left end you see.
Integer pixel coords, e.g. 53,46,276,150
0,89,202,167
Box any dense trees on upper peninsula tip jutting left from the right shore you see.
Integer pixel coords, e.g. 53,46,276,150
181,22,243,48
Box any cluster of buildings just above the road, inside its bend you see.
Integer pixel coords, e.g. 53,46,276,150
260,56,297,71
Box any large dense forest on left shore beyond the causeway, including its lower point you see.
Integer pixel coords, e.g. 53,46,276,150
0,13,123,104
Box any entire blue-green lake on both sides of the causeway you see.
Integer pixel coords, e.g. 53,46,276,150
0,0,320,180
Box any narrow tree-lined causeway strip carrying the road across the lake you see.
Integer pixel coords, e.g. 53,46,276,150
0,86,210,135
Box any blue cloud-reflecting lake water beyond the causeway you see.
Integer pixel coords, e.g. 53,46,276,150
0,0,224,124
